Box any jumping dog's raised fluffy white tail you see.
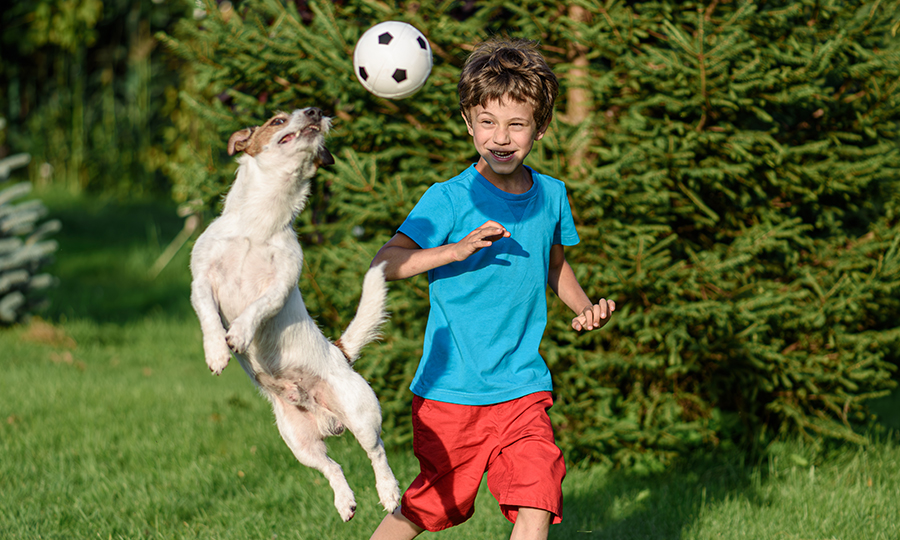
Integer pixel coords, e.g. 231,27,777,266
335,263,387,365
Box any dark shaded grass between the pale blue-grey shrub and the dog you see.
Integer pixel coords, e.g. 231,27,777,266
40,192,192,323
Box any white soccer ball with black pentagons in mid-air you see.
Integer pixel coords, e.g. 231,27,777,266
353,21,431,99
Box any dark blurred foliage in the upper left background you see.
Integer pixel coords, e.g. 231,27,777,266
0,0,192,195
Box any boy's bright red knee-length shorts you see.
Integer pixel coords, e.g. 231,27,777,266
400,392,566,532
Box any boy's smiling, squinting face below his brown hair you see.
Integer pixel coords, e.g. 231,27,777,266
463,99,547,187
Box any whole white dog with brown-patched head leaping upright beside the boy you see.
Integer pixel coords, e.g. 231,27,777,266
191,108,400,521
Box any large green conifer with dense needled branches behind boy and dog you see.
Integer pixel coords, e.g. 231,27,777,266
159,0,900,471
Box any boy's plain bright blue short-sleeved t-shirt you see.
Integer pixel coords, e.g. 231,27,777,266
399,165,579,405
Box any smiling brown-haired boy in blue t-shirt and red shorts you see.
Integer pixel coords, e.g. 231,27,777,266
372,40,615,539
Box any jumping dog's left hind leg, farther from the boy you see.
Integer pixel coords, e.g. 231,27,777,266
270,395,356,521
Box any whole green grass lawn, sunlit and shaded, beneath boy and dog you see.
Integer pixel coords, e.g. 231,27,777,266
0,189,900,540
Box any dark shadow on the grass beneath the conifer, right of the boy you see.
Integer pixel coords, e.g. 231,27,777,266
550,390,900,540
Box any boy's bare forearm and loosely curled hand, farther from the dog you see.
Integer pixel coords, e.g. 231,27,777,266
547,244,616,331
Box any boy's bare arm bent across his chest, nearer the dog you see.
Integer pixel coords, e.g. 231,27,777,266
372,221,509,281
